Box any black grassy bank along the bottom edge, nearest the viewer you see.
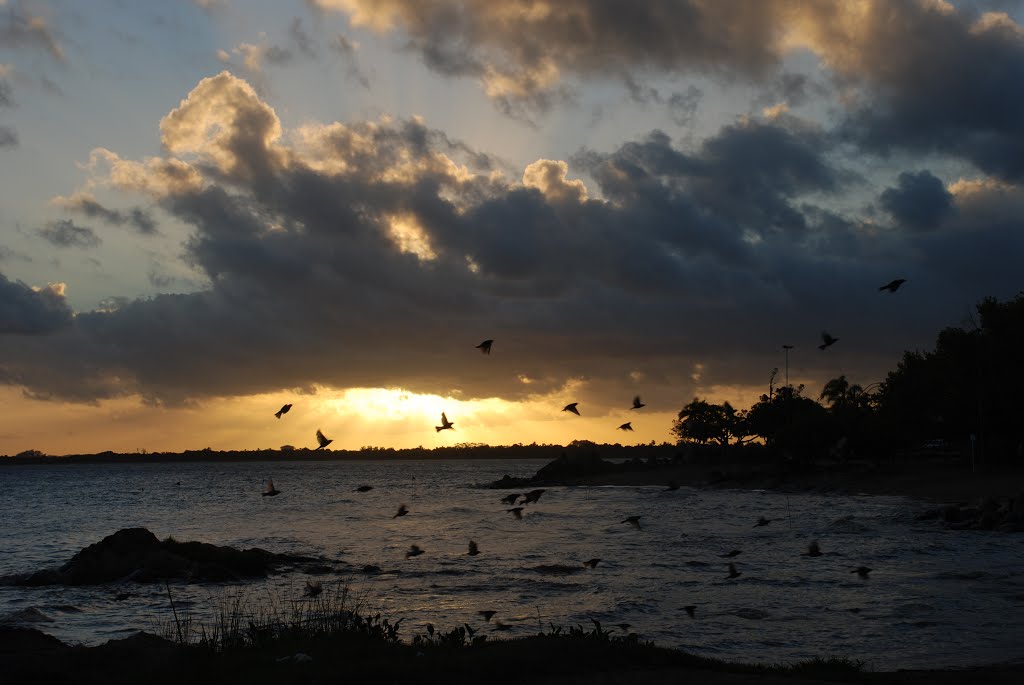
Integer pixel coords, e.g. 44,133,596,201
0,628,1024,685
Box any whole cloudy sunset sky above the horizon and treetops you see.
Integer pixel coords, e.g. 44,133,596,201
0,0,1024,455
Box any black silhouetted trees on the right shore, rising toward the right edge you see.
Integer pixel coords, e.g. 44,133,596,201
672,292,1024,461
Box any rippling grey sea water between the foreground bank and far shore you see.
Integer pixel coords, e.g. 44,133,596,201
0,460,1024,670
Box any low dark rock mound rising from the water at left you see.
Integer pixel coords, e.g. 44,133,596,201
0,528,323,586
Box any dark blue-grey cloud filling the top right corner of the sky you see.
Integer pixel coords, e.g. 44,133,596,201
836,2,1024,179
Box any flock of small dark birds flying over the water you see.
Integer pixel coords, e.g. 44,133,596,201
263,279,906,632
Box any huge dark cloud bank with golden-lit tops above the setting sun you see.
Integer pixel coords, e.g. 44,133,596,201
0,73,1024,411
